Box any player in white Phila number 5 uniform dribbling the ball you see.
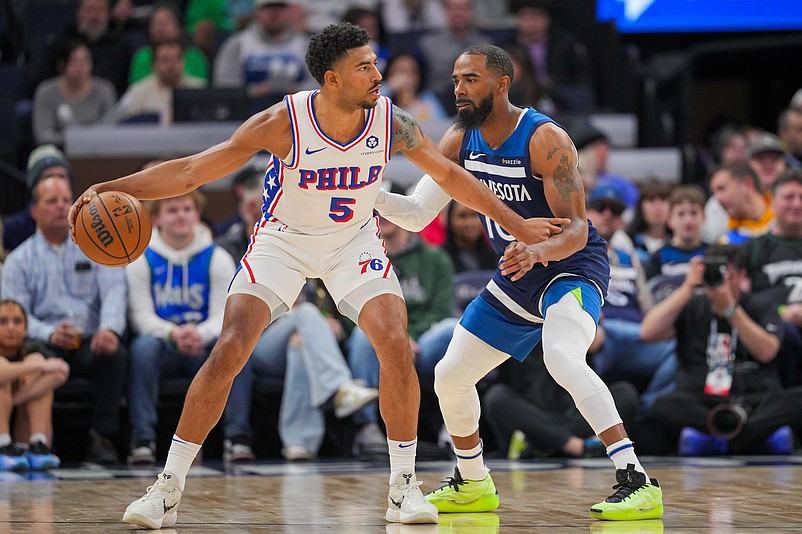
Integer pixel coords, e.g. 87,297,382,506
70,23,567,529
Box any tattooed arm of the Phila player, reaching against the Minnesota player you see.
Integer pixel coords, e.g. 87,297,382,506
393,106,562,243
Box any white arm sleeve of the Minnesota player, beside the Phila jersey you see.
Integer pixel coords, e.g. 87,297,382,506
376,174,451,232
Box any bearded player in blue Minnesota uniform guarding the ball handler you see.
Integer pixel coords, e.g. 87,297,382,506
377,45,663,520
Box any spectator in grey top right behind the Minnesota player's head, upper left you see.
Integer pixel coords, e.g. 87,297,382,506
418,0,490,98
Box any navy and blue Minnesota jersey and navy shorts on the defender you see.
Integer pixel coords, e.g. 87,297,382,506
459,108,610,324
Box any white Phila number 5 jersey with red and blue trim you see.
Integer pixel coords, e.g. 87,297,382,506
262,91,393,235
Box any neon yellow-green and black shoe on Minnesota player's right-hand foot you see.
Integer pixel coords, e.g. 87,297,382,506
590,464,663,521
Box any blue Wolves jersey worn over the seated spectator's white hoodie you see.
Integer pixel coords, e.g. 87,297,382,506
145,245,216,324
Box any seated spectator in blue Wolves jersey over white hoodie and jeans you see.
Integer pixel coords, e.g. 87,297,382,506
125,191,253,465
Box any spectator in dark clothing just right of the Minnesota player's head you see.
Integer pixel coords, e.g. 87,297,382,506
511,0,596,113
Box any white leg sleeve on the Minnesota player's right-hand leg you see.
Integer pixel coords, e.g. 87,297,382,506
543,293,621,435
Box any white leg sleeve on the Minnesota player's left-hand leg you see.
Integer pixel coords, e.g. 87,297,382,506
434,325,509,437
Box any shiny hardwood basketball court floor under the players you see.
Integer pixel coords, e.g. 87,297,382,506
0,456,802,534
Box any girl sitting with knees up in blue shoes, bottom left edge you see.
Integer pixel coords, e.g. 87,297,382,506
0,299,70,470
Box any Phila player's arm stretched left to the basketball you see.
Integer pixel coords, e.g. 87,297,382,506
69,104,291,240
